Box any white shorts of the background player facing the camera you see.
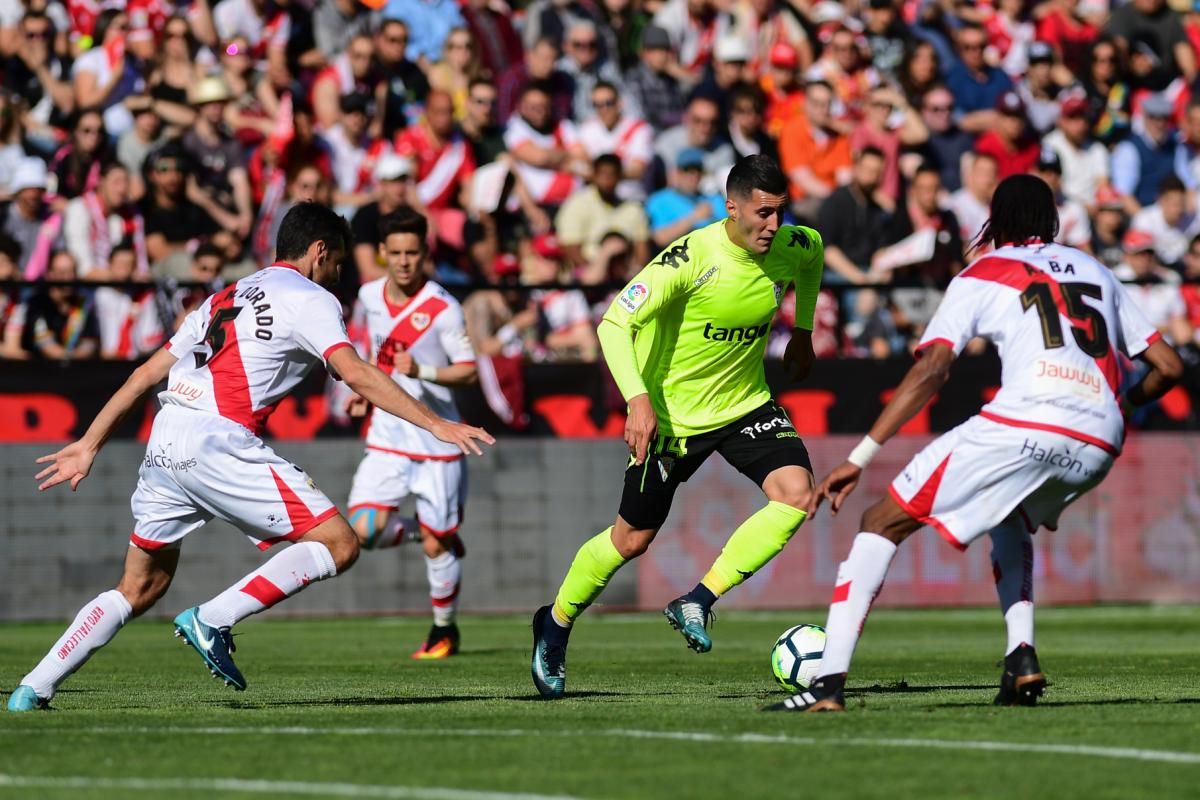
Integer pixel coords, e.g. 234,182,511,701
349,447,467,536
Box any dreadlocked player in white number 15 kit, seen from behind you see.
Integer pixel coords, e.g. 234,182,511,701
767,175,1183,711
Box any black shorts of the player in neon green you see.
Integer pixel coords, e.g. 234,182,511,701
620,401,812,530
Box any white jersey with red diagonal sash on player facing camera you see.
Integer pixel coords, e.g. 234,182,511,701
356,277,475,461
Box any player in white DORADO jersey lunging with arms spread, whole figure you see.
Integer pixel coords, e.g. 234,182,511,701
8,204,492,711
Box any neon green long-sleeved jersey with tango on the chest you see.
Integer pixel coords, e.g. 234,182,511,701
599,219,824,437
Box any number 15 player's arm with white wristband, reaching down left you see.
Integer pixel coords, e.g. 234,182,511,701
809,342,954,515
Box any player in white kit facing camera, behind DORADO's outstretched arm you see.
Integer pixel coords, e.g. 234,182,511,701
347,209,476,660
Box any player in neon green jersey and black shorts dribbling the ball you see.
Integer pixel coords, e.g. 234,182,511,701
532,156,824,698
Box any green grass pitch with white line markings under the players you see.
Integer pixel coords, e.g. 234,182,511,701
0,607,1200,800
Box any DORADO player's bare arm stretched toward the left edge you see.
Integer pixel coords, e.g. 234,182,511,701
36,348,178,492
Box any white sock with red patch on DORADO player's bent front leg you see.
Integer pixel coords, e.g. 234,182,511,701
200,542,337,627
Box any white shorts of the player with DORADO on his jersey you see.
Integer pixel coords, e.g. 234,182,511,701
130,405,337,551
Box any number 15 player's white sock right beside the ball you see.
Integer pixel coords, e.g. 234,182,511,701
821,531,896,676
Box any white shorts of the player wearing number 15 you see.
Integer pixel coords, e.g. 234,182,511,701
888,416,1114,549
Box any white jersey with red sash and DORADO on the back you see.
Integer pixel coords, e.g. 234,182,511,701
158,264,350,433
